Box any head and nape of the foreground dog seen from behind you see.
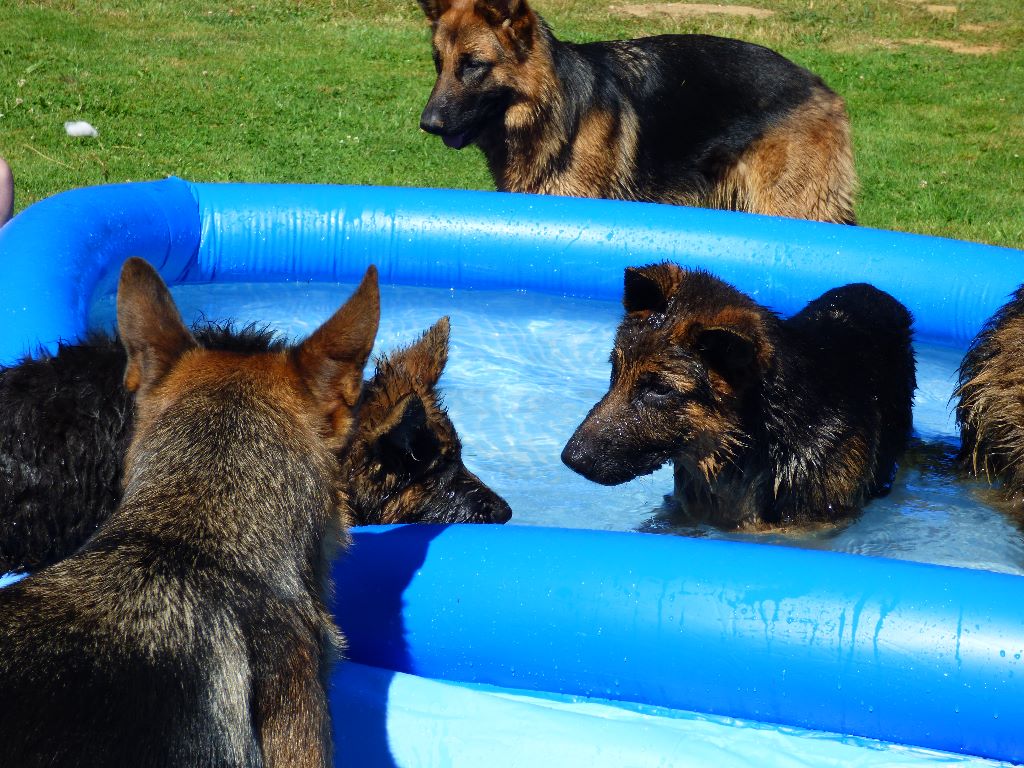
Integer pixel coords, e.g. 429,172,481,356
117,258,380,547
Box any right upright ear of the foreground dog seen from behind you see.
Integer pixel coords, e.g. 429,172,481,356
292,265,380,428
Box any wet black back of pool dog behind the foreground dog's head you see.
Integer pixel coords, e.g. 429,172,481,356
0,326,284,571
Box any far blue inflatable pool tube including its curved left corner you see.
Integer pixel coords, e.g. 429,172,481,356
0,178,1024,362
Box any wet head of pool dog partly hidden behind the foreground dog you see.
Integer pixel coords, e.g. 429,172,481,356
348,317,512,524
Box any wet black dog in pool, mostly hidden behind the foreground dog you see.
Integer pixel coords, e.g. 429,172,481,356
0,318,512,573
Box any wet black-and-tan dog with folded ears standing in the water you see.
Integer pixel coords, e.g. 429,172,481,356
562,263,915,529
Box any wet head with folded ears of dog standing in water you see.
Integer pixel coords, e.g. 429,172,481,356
562,264,773,485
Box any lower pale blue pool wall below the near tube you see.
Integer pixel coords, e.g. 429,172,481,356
333,662,1009,768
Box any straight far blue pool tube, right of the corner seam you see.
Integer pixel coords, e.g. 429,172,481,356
180,184,1024,343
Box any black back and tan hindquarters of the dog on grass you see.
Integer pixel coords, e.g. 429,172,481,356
570,35,856,223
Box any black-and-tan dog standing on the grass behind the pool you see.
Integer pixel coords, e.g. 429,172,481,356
419,0,857,224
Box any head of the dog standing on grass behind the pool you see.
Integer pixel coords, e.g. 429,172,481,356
420,0,549,150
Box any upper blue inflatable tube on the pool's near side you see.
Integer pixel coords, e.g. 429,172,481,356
335,525,1024,761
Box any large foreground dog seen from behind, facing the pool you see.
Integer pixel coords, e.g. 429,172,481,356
0,259,379,768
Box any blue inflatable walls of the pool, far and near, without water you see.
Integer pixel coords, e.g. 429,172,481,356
0,178,1024,767
